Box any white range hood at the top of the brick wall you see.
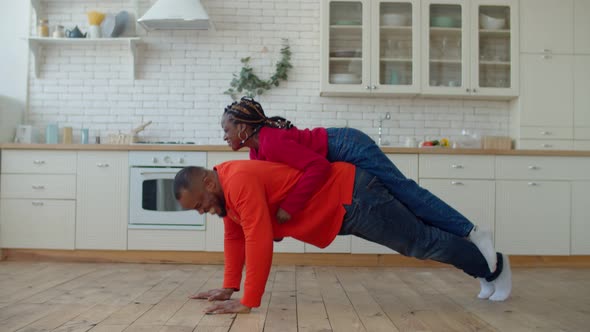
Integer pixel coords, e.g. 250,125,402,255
137,0,211,31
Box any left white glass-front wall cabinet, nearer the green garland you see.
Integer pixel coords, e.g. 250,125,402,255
320,0,420,95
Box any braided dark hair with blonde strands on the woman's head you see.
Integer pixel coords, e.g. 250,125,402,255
223,97,293,132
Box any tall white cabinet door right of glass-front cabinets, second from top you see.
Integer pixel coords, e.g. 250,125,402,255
520,54,574,127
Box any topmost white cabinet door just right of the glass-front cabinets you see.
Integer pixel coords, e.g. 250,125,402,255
520,0,572,53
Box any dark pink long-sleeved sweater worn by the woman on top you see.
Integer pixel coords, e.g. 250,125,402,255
250,127,330,216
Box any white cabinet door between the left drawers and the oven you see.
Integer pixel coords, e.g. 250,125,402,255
76,151,129,250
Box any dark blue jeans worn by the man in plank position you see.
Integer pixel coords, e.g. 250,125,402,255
339,167,495,279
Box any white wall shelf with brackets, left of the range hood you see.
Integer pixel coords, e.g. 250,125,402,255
27,37,141,79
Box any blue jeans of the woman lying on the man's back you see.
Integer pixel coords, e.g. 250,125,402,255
327,128,474,237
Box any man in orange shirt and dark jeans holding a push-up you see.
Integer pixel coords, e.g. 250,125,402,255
174,160,512,313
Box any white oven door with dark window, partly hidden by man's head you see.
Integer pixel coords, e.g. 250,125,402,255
129,167,205,229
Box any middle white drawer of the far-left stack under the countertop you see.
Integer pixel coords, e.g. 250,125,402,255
0,174,76,199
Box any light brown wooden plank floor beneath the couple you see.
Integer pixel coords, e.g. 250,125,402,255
0,262,590,332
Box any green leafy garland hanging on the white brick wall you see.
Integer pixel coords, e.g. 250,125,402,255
224,39,293,100
